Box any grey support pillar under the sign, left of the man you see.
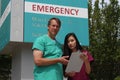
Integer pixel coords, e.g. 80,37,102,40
12,43,34,80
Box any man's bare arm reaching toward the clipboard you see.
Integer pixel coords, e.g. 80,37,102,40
33,49,68,66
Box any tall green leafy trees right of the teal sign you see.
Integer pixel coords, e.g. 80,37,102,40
89,0,120,80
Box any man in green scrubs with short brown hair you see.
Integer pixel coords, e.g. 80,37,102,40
32,18,68,80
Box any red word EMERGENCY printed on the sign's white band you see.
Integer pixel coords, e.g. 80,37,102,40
32,4,79,16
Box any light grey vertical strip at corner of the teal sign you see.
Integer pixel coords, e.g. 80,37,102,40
10,0,24,42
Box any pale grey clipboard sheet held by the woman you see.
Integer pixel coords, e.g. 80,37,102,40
65,51,83,72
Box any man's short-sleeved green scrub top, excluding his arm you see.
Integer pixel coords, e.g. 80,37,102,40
32,35,63,80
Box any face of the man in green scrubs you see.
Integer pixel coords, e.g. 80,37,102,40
48,20,60,37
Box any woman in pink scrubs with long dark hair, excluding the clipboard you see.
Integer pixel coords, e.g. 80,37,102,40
64,33,93,80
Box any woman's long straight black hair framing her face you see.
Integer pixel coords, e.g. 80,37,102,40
63,33,83,56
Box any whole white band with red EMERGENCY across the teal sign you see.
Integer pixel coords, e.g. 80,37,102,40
25,2,88,18
